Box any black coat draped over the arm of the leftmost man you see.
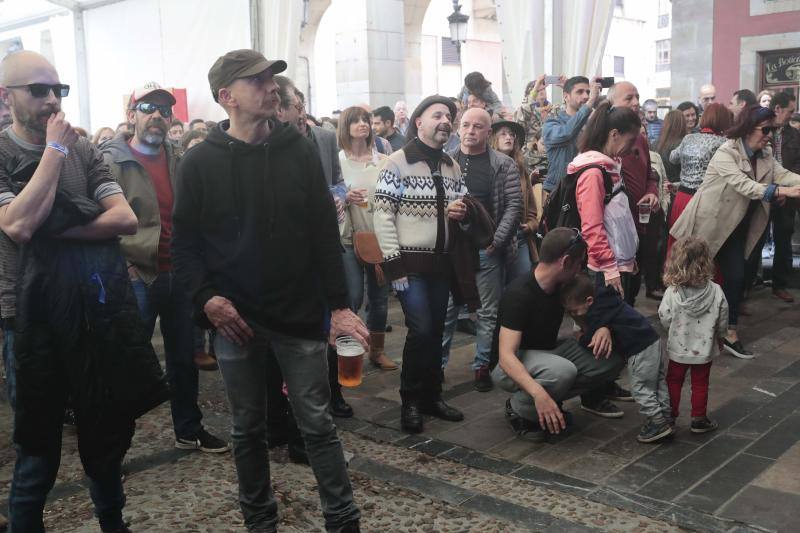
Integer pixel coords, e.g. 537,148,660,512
14,186,169,460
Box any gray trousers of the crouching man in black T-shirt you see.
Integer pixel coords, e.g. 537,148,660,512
492,339,625,422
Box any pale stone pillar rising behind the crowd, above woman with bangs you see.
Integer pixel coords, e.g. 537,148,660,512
334,0,405,109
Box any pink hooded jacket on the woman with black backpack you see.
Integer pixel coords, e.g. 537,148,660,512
567,151,638,280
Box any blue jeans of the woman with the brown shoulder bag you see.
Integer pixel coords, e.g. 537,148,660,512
342,246,389,333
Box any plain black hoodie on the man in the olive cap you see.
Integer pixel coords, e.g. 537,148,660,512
172,120,348,339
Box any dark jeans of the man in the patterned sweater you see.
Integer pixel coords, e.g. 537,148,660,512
397,274,450,402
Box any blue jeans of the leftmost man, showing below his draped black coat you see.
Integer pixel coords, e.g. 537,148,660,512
3,328,127,533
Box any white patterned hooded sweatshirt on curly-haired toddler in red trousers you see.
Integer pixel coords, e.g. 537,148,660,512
658,280,728,365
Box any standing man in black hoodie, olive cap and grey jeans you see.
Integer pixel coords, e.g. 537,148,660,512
171,50,369,533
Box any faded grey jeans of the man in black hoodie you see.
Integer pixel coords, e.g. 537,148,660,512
214,324,360,531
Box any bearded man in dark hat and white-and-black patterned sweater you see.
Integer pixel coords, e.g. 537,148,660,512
374,95,466,433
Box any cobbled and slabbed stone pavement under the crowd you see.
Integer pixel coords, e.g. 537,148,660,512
0,284,800,533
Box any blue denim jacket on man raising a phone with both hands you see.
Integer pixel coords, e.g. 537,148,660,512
542,105,592,192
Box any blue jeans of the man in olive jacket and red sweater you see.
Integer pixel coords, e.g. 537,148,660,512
131,272,203,440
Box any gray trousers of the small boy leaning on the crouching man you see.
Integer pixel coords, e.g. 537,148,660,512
628,340,672,424
